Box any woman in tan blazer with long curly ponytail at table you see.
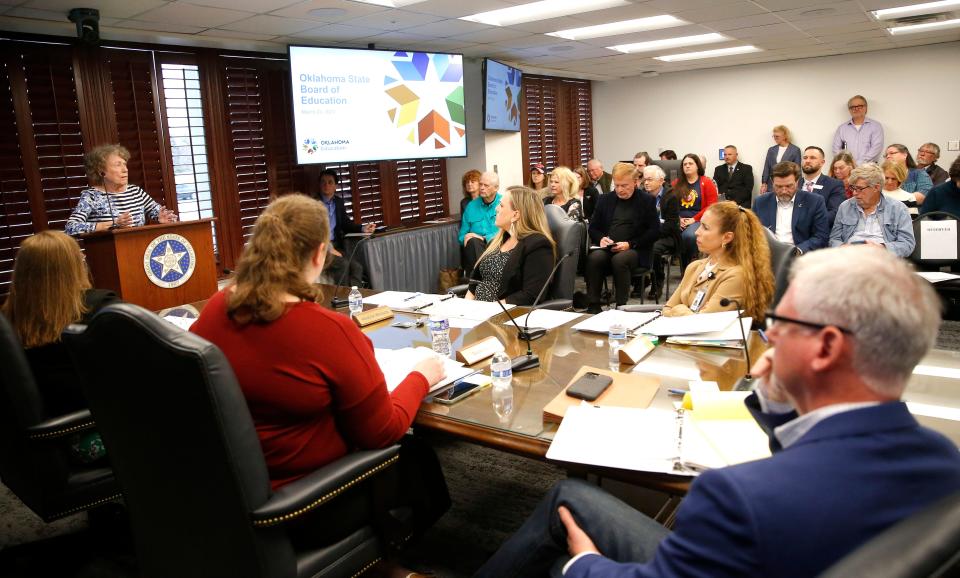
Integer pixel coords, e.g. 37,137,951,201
663,201,774,320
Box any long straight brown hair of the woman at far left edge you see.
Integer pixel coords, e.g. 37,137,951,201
3,230,90,348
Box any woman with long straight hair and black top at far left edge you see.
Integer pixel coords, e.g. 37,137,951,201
3,230,118,462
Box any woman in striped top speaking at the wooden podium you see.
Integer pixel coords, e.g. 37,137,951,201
64,145,177,236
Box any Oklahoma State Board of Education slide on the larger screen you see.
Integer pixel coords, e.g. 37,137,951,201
289,46,467,164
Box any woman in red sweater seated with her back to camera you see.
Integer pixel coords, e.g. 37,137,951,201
190,195,443,489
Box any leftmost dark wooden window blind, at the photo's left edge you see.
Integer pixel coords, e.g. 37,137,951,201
0,62,34,301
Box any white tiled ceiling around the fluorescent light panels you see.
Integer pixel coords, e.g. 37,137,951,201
0,0,960,80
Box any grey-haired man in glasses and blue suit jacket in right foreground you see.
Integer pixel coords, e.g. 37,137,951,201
478,246,960,578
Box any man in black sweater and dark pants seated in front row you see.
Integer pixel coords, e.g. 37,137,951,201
586,163,660,313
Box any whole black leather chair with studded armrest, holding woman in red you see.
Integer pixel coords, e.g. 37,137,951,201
64,303,399,578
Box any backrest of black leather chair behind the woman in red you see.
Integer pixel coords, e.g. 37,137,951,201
64,303,296,578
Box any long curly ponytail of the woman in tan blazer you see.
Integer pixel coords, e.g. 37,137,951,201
707,201,774,321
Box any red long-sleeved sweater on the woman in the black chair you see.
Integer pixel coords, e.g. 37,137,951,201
190,290,428,489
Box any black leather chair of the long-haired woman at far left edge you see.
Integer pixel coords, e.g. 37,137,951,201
0,314,120,522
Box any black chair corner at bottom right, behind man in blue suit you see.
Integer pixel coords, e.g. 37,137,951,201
820,486,960,578
